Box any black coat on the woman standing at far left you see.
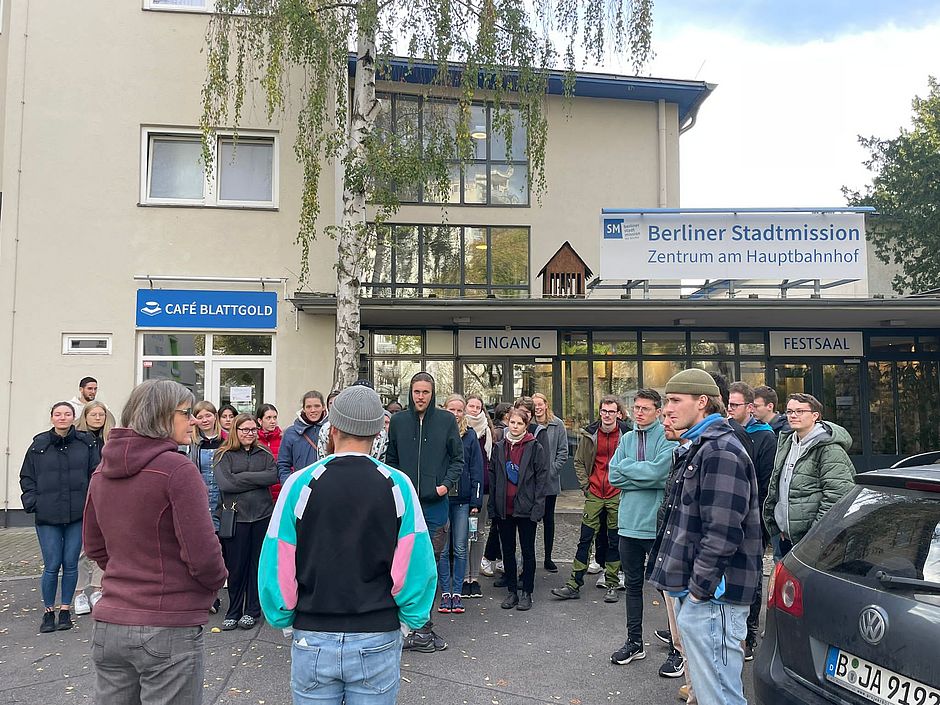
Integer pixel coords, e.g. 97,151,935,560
20,426,101,524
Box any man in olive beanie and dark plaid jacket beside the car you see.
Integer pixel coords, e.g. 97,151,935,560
647,369,763,705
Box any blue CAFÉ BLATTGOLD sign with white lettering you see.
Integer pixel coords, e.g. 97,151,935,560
137,289,277,328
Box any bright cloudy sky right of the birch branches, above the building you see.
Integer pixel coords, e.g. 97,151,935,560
604,0,940,208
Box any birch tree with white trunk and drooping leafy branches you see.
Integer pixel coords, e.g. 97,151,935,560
202,0,652,389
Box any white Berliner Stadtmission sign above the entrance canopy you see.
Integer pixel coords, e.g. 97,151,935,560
600,209,868,280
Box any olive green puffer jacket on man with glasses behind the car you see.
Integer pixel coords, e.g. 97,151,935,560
763,421,855,543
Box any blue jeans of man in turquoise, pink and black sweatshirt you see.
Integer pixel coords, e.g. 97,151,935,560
290,629,402,705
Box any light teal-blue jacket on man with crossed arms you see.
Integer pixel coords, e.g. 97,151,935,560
608,420,677,539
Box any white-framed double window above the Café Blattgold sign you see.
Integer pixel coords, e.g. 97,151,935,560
140,128,277,208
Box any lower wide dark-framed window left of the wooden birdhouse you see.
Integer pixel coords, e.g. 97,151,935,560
363,225,529,298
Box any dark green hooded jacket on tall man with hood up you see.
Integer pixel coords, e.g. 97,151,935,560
385,384,464,506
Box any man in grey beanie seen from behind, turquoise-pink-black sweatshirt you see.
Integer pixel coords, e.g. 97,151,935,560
258,386,437,705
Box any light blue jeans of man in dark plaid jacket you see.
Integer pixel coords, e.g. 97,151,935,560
676,597,750,705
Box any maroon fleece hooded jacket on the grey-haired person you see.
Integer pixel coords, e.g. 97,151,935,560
82,428,227,627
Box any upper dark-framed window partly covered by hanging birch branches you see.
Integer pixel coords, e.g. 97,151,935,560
378,93,529,206
